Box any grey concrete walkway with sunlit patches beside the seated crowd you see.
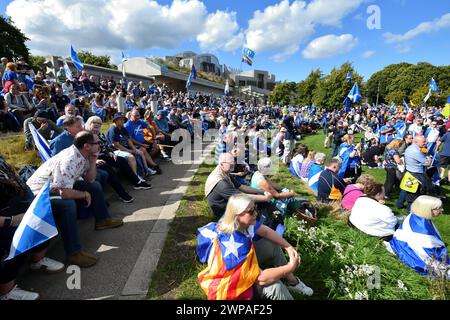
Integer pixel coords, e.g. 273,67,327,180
18,144,211,300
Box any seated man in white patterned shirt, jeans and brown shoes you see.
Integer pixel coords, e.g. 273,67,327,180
27,131,123,267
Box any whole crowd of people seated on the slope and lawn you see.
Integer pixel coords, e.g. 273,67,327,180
0,55,450,299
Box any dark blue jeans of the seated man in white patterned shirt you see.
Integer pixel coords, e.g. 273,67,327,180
51,181,110,256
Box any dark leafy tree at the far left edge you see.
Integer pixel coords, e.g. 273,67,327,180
0,15,30,61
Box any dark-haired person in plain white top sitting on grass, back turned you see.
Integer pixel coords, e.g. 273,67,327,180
349,181,398,241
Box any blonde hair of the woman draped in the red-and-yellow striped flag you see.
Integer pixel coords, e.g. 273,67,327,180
217,193,252,234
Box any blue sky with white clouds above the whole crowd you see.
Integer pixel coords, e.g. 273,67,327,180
0,0,450,82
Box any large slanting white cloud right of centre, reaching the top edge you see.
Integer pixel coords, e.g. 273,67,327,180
246,0,363,62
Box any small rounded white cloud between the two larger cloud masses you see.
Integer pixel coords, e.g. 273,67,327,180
197,11,244,51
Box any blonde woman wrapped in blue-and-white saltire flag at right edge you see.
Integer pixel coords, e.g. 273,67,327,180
388,196,450,278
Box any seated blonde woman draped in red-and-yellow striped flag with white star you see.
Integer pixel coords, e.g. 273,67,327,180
197,194,313,300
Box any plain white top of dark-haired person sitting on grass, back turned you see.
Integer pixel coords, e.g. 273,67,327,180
349,196,397,237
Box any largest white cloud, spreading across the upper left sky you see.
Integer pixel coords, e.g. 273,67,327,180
6,0,207,56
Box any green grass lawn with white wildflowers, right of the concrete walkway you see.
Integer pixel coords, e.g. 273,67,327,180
148,130,450,300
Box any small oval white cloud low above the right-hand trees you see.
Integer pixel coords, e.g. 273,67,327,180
303,34,358,59
